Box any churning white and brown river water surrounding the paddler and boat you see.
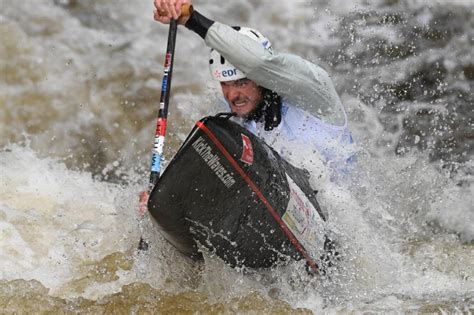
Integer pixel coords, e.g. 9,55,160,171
0,0,474,314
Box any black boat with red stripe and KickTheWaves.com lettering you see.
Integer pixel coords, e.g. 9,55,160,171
148,114,326,272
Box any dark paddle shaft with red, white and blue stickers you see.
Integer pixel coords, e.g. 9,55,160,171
138,4,193,250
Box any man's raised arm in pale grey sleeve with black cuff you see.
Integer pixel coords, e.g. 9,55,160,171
185,11,345,125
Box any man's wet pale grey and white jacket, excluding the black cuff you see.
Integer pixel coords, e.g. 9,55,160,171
205,22,354,172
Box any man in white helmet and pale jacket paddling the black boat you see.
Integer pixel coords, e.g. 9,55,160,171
154,0,355,177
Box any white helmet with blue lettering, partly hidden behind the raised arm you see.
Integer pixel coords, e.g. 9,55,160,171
209,26,273,82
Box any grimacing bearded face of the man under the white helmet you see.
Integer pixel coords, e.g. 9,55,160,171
221,79,262,117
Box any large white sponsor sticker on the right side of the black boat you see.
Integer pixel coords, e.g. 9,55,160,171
282,174,324,251
